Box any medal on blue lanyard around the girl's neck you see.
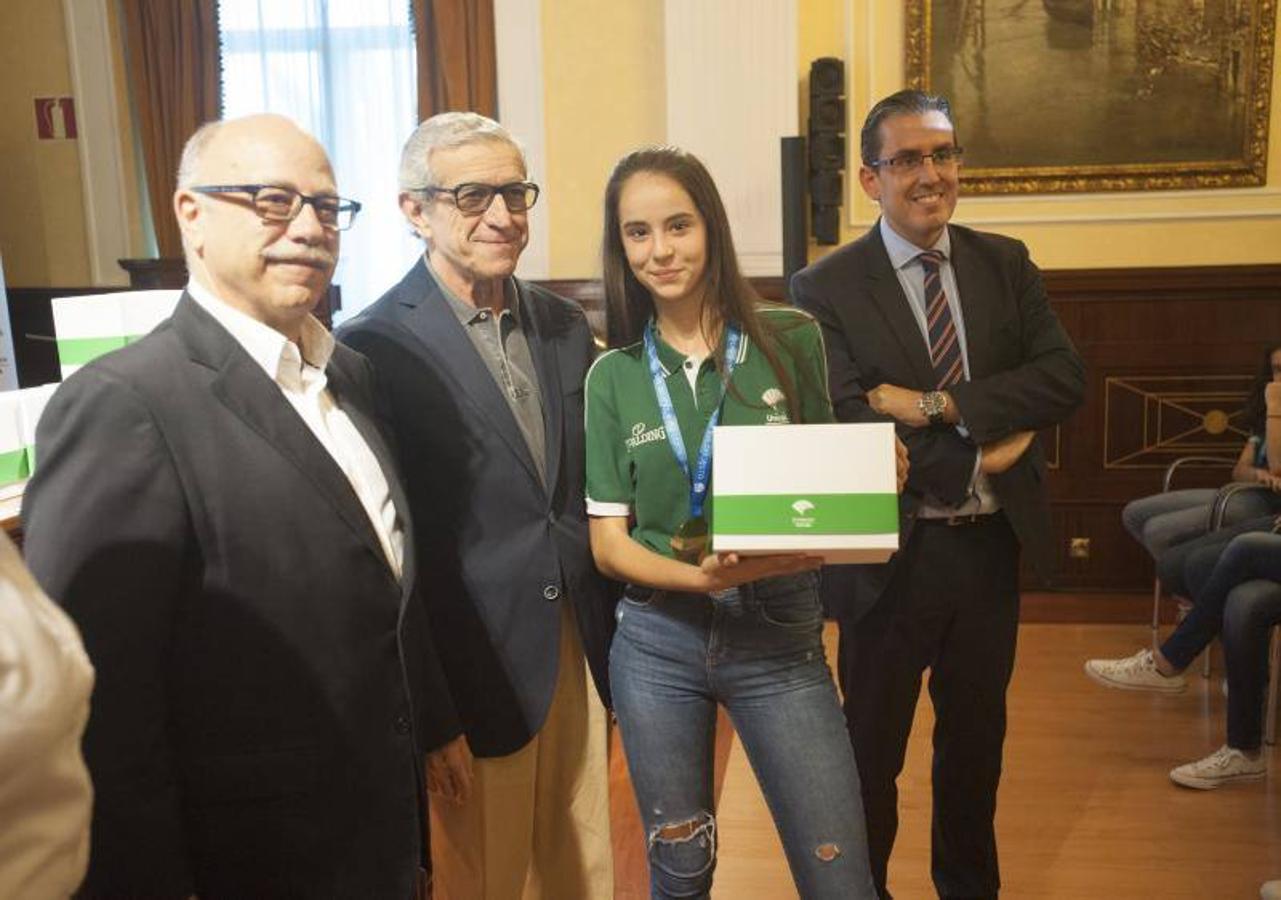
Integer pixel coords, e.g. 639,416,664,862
644,320,743,565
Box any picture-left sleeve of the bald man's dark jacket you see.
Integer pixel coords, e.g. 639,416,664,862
23,367,194,897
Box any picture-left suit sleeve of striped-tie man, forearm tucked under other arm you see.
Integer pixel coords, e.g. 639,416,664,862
792,270,977,506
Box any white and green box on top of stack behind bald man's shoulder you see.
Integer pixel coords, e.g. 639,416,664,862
53,291,182,380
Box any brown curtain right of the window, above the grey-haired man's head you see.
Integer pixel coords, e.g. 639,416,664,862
411,0,498,119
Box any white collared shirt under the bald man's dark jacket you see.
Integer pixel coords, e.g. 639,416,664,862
187,279,405,579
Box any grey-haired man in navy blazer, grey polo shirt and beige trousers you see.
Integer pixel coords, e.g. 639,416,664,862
339,113,614,900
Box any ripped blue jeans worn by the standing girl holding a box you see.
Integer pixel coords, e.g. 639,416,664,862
610,574,876,900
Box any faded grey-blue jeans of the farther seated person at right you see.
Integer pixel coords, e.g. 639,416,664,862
1121,488,1281,560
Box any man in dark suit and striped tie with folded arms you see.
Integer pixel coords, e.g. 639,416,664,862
792,91,1084,897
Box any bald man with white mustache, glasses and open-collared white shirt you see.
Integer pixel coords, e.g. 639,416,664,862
23,117,459,900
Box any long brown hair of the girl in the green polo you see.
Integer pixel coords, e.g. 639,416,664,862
601,146,801,421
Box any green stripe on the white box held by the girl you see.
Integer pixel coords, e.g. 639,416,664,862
712,494,898,535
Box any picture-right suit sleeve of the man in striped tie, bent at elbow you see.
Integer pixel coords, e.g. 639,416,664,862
949,242,1085,444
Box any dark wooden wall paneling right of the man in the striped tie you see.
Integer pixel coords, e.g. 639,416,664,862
1044,265,1281,591
